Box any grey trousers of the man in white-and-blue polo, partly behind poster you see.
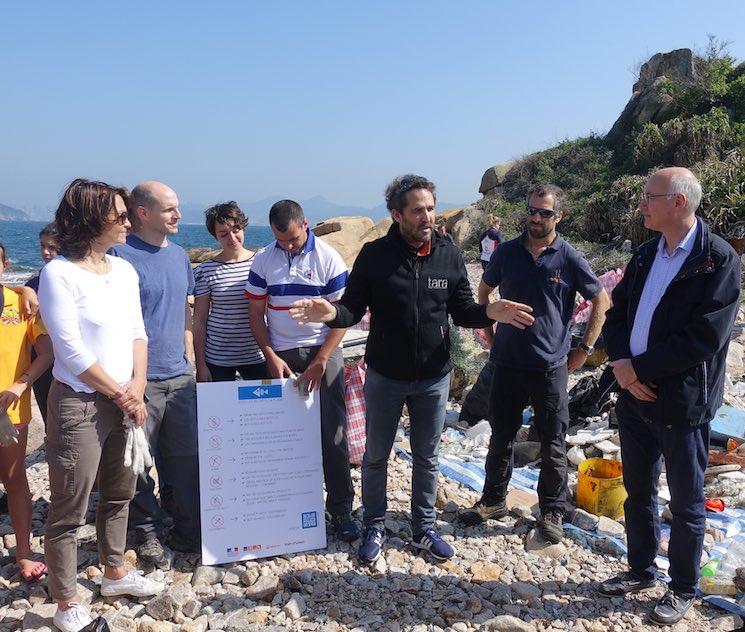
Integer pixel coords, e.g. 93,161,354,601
277,346,354,516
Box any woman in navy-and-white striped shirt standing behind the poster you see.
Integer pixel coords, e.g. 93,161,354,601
194,202,267,382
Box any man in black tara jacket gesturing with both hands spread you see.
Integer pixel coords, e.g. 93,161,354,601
291,174,533,562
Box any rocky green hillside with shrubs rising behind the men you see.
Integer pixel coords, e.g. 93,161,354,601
448,39,745,262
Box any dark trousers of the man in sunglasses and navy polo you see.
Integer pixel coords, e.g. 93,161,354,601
482,364,569,513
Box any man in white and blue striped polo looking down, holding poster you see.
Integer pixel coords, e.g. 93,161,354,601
246,200,359,542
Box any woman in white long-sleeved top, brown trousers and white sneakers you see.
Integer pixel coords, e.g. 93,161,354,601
39,179,163,632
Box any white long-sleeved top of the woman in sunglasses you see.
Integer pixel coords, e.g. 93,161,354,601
39,256,148,393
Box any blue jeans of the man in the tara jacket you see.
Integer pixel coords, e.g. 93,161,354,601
362,367,450,534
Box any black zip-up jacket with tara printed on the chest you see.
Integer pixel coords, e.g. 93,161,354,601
327,222,494,380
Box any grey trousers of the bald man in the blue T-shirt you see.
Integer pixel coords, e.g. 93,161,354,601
129,373,200,550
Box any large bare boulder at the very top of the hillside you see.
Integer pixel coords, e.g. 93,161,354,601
606,48,696,143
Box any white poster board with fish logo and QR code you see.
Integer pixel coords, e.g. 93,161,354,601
197,380,326,565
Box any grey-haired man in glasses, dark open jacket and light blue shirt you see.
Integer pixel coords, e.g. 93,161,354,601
599,167,740,625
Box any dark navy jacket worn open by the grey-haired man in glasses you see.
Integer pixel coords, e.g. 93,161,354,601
603,218,740,426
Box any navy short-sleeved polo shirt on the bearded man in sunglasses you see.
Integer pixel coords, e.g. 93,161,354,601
483,233,602,371
